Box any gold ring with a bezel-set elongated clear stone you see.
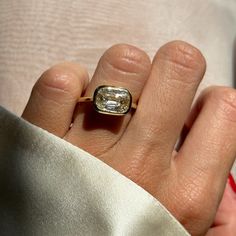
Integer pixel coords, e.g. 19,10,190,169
78,85,137,116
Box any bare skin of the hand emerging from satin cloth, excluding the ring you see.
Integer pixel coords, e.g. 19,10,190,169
22,41,236,235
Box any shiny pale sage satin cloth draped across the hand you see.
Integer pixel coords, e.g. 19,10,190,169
0,107,189,236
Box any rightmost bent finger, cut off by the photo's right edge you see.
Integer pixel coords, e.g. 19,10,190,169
178,87,236,203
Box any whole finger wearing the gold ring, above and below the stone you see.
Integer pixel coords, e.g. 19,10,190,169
66,44,151,156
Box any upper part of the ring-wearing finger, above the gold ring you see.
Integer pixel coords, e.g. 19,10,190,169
85,44,151,103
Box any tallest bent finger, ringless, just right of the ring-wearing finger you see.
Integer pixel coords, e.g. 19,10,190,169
122,41,205,164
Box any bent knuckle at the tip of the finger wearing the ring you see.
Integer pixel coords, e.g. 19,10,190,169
101,44,151,73
